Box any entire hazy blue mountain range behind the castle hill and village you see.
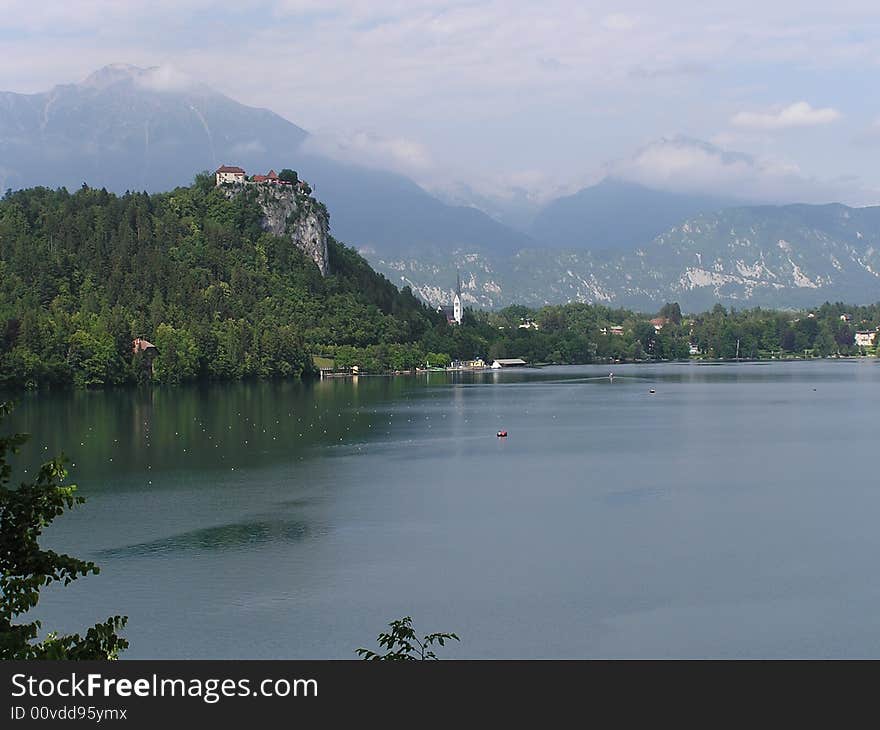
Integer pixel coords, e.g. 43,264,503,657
0,64,880,311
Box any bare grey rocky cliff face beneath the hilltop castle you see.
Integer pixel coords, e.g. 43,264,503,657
223,182,330,276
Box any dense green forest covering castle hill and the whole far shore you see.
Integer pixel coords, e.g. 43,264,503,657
0,175,880,388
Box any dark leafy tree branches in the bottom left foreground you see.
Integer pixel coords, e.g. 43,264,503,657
0,403,128,660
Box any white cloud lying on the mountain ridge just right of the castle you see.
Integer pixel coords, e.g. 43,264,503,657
303,131,433,175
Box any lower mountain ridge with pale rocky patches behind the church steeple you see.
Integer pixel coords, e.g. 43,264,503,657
377,204,880,312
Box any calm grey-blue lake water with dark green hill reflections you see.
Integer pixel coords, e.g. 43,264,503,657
5,361,880,658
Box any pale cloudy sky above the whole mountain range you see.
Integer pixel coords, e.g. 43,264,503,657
0,0,880,204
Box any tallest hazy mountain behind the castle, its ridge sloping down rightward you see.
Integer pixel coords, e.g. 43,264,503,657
0,64,530,254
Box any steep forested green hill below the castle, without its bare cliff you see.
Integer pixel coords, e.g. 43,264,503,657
0,175,438,387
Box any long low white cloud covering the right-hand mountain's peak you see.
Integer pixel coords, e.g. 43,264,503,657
607,137,877,205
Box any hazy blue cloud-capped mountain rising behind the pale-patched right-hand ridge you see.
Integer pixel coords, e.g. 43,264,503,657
529,178,733,251
